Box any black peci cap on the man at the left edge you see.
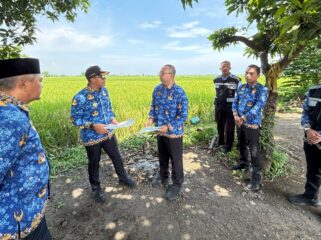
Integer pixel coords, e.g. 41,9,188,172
0,58,40,79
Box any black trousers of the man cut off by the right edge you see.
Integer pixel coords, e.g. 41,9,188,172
304,142,321,199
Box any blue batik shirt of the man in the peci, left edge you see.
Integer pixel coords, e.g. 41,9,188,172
0,93,49,239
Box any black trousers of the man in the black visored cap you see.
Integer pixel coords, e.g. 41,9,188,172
86,135,127,190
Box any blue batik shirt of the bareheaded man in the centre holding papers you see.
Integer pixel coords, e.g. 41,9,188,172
149,83,188,138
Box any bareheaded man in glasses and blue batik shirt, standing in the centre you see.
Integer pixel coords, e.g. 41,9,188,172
145,64,188,201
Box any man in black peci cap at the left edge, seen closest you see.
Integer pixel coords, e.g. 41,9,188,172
0,58,51,240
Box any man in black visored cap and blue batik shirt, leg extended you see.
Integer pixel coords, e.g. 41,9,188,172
71,66,136,203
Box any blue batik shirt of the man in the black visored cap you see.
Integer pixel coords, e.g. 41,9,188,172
71,86,115,146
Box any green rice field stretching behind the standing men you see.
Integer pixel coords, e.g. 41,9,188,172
31,75,214,148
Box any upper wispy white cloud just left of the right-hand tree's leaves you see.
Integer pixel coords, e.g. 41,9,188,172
168,21,211,38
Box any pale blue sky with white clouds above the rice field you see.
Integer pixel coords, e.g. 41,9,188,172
23,0,259,75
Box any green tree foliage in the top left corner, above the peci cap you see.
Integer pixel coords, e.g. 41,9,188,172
0,0,90,58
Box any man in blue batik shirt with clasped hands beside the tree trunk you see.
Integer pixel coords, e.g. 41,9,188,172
232,65,267,191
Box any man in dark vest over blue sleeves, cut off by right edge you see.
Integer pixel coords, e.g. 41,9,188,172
289,84,321,207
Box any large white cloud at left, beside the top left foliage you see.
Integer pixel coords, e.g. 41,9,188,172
26,26,113,52
